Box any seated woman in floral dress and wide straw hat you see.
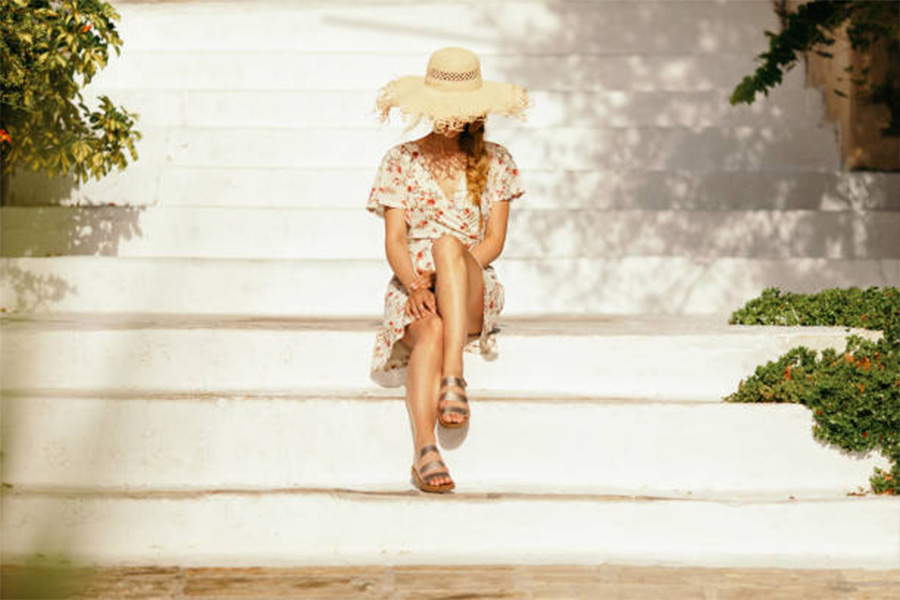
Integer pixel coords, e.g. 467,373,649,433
367,47,529,492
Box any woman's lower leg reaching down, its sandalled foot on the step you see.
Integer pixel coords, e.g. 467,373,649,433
400,314,451,485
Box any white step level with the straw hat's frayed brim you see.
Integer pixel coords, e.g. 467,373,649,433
79,86,825,128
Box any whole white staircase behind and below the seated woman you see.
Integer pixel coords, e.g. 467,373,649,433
0,0,900,569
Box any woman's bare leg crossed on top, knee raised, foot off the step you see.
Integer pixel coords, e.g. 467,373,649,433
432,234,484,421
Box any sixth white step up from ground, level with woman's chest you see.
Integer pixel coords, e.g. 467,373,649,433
10,168,900,210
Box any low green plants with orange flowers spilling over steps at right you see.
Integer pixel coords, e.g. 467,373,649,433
725,287,900,494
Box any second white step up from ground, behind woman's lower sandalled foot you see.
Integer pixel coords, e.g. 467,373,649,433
3,394,890,500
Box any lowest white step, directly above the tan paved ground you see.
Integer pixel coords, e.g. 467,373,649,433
2,485,900,569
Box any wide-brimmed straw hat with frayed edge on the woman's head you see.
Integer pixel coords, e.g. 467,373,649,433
375,46,531,133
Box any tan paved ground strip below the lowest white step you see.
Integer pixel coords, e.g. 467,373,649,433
0,565,900,600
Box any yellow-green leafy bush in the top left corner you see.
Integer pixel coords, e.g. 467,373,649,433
0,0,141,193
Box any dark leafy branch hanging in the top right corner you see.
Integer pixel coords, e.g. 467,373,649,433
729,0,900,135
